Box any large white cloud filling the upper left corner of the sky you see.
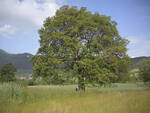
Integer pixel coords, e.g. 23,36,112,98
0,0,59,29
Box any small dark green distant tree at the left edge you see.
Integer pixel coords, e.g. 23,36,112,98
0,63,17,82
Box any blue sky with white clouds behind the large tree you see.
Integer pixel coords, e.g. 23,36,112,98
0,0,150,57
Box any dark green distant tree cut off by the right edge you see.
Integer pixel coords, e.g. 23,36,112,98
139,59,150,83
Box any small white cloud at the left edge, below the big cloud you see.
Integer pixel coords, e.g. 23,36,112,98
0,24,16,37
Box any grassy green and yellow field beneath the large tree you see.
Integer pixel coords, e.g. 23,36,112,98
0,83,150,113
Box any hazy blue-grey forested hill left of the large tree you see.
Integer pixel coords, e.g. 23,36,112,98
0,49,33,73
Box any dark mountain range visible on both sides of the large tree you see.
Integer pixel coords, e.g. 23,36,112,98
0,49,150,74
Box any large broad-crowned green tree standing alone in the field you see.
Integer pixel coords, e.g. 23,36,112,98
32,5,129,90
